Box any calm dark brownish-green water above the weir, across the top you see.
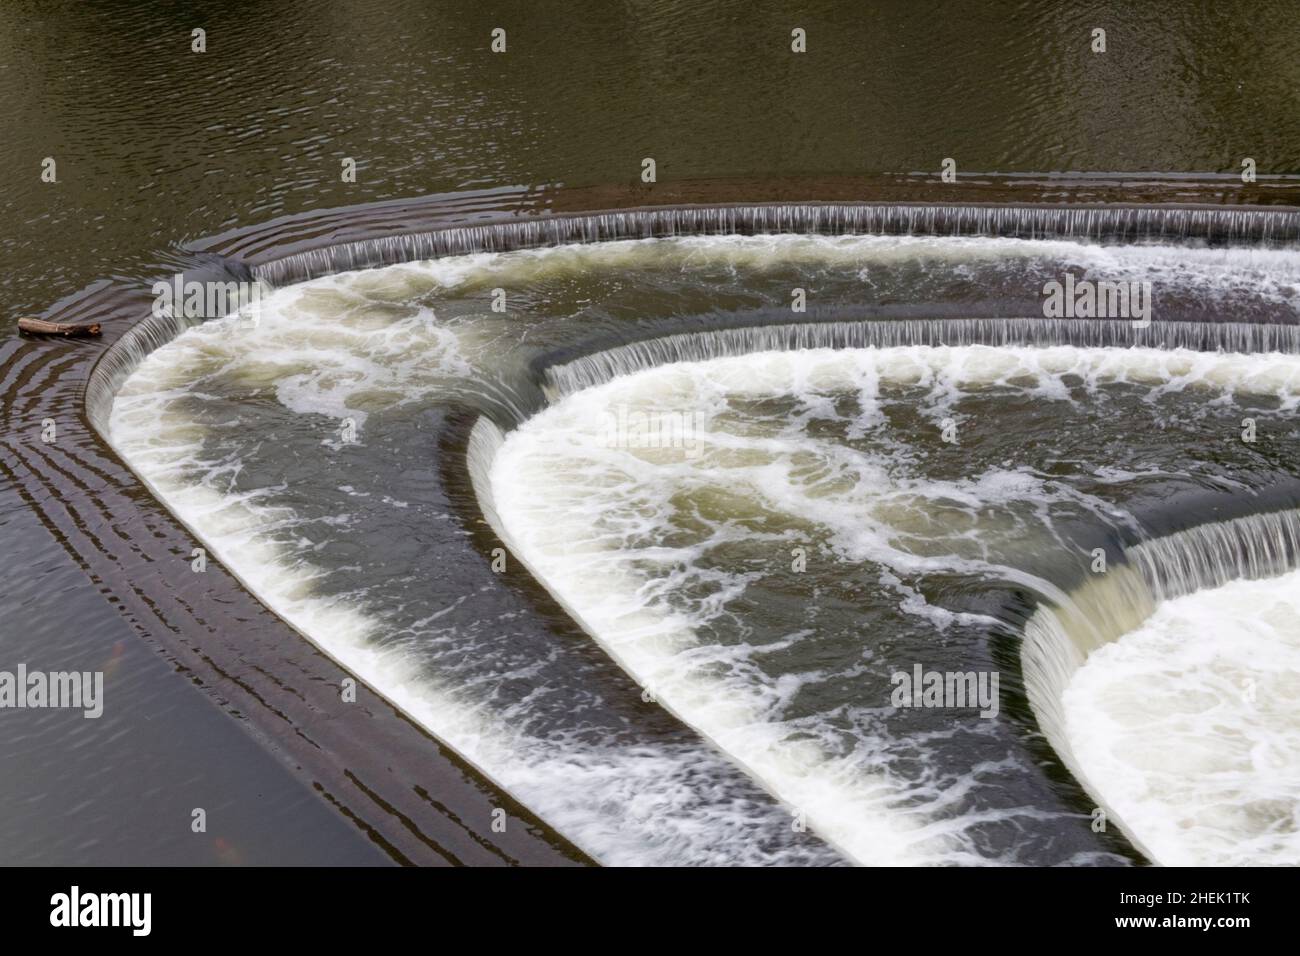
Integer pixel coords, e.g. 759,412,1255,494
0,0,1300,312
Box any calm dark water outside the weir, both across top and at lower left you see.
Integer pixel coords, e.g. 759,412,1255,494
0,3,1300,864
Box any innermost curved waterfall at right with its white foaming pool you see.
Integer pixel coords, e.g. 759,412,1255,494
1023,510,1300,865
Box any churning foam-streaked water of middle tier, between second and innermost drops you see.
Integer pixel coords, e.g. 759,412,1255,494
493,347,1300,862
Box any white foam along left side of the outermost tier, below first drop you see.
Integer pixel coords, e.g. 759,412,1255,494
109,269,828,865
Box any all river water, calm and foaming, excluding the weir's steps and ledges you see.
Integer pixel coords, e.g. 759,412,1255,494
0,1,1300,862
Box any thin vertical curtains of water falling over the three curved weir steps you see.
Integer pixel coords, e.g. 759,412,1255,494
68,203,1300,868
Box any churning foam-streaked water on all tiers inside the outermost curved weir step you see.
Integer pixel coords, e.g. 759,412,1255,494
109,237,1300,864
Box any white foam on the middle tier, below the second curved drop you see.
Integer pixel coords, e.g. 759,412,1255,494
491,346,1300,862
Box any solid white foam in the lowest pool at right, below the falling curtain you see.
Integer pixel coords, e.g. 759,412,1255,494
1063,572,1300,866
